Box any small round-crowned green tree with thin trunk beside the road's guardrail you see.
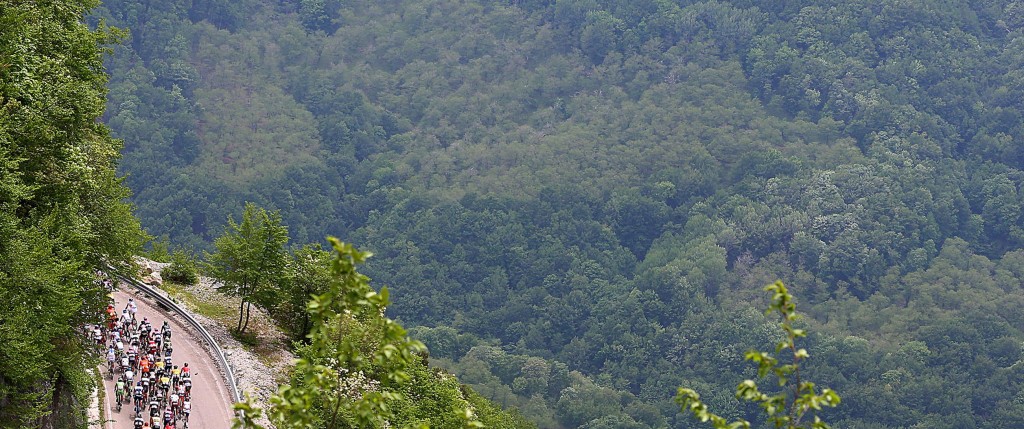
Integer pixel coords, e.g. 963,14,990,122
205,203,288,334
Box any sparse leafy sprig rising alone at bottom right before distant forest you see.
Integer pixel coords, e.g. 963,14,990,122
676,282,840,429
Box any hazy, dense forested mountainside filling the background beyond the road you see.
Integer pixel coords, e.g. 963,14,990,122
94,0,1024,429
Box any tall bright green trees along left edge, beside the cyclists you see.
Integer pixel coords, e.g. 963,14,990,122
0,0,144,428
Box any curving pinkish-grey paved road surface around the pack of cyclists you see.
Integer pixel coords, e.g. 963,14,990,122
101,291,232,429
